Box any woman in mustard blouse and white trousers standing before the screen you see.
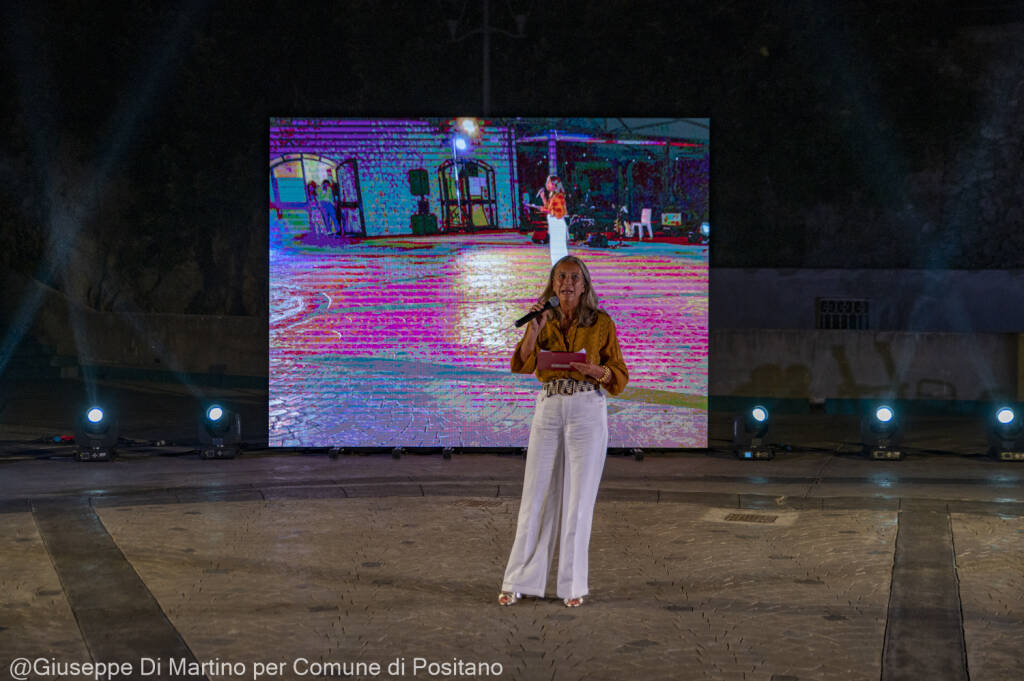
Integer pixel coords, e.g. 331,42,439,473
498,255,629,607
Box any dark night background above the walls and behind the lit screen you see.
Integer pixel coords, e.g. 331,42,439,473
0,0,1024,316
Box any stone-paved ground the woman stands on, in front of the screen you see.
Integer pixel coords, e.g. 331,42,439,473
0,376,1024,681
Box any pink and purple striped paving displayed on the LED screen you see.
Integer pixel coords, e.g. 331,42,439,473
269,231,709,448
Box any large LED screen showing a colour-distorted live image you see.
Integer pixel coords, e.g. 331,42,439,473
268,118,712,448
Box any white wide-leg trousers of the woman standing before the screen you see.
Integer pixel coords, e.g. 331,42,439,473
502,390,608,598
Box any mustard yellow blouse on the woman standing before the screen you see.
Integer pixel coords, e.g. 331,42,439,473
512,311,630,395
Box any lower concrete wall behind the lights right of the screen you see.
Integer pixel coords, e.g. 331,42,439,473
709,329,1024,400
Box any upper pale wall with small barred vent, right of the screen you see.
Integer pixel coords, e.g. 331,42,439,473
710,267,1024,333
